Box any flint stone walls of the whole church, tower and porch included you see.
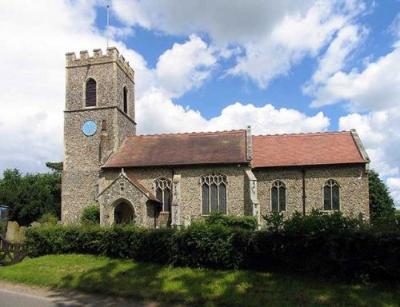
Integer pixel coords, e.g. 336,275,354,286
62,48,369,227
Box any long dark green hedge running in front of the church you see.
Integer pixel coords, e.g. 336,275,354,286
26,217,400,281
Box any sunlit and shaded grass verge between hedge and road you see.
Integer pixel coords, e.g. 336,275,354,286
0,255,400,306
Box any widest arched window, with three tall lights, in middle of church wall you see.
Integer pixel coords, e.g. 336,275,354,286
200,175,227,214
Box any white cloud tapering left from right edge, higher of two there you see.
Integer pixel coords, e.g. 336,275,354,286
312,41,400,111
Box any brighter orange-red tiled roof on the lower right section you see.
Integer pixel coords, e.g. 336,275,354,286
252,131,367,168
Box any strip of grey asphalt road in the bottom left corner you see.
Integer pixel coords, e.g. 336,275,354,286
0,283,160,307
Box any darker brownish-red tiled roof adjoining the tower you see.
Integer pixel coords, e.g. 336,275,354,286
103,130,249,168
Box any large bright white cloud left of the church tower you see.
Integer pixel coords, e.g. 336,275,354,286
0,1,104,171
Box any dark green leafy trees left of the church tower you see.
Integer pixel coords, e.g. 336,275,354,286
0,169,61,225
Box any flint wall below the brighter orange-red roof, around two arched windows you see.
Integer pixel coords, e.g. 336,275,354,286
254,165,369,223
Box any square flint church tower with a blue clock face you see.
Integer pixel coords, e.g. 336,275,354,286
61,48,136,223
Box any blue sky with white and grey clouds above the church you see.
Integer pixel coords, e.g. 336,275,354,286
0,0,400,207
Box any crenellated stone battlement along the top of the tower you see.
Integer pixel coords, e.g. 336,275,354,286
65,47,135,80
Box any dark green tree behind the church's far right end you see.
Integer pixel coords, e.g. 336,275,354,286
369,170,395,221
